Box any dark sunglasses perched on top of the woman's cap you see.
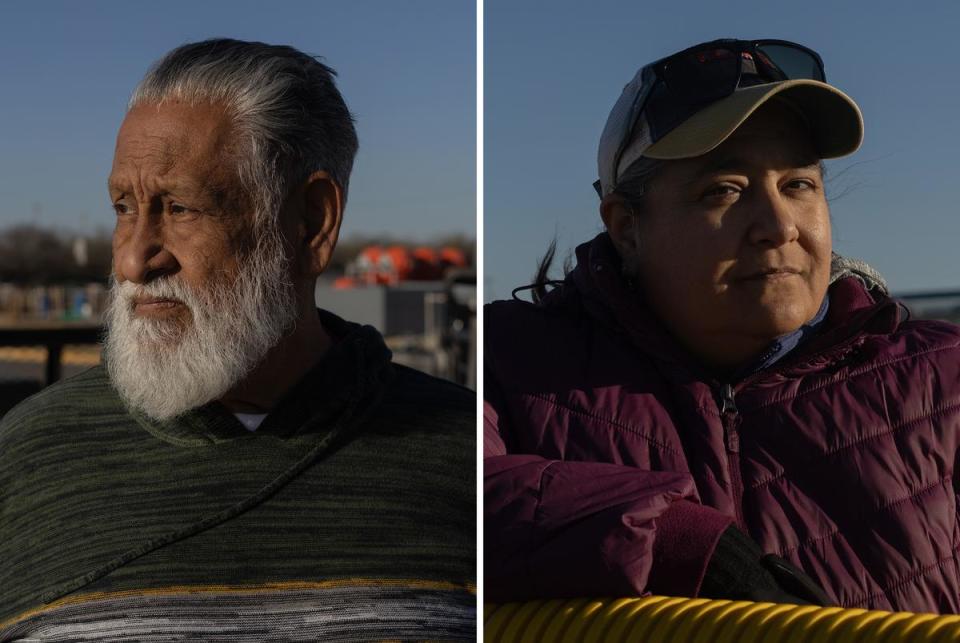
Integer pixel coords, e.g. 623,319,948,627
594,39,826,196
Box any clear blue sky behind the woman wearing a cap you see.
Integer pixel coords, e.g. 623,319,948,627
484,0,960,301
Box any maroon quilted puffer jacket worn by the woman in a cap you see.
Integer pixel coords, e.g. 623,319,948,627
484,235,960,612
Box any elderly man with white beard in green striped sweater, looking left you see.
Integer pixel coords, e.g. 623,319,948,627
0,40,476,641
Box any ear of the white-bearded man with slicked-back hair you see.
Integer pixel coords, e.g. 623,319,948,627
299,171,343,276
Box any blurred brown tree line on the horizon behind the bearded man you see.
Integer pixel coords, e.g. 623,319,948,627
0,223,476,285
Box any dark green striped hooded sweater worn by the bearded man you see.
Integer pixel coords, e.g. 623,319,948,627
0,314,476,641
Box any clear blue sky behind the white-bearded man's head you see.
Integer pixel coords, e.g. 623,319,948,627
0,0,476,239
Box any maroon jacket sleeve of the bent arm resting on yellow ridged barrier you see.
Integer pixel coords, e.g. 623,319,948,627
484,394,731,602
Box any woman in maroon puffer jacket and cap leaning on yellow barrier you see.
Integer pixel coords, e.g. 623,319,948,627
484,40,960,612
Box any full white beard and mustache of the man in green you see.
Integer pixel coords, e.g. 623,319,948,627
104,233,296,420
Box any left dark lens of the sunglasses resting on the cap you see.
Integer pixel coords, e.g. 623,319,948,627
663,48,740,104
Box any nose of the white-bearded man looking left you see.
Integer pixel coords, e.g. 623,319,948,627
114,213,179,284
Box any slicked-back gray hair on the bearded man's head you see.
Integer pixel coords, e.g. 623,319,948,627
128,38,357,228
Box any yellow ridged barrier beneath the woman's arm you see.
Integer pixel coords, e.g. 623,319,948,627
483,596,960,643
